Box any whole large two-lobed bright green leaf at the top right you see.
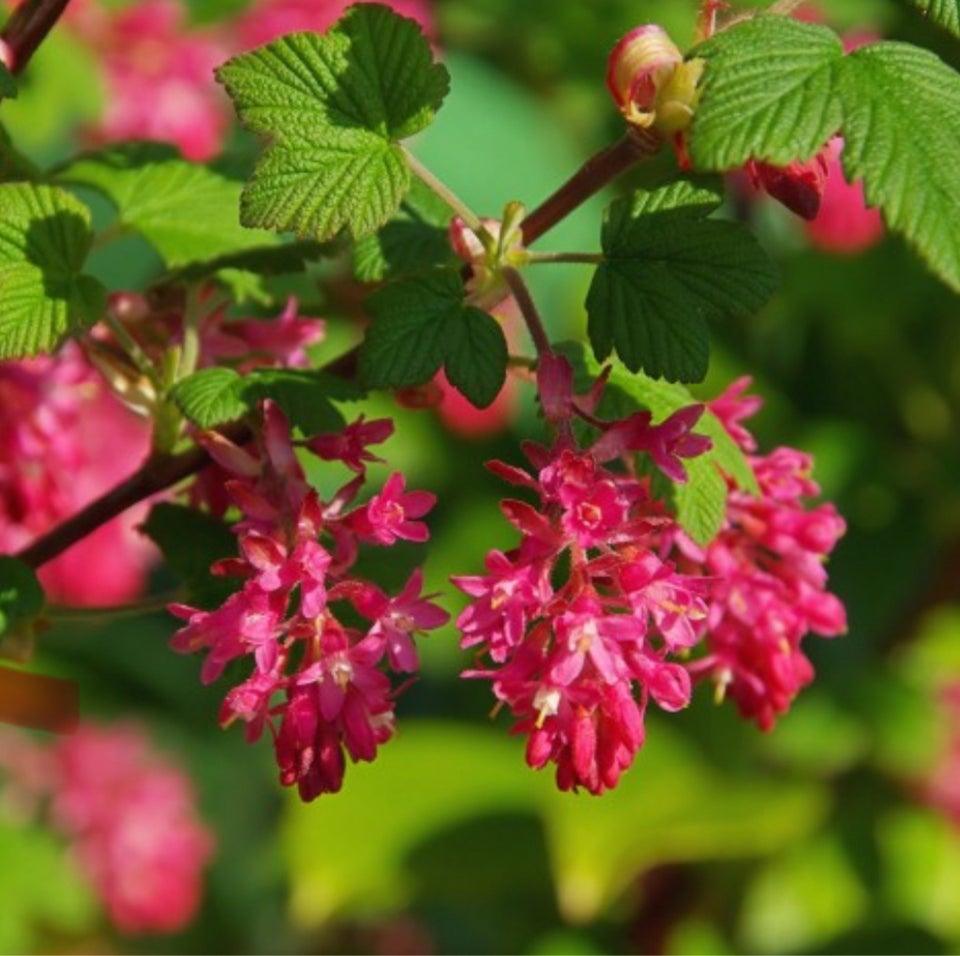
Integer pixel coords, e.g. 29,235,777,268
690,12,960,291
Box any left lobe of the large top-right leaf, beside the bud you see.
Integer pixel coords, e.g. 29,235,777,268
690,15,843,170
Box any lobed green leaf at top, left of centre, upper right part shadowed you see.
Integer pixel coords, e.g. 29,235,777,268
217,4,449,240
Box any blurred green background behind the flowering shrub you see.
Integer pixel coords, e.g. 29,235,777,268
0,0,960,954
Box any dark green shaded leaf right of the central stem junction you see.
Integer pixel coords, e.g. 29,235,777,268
587,180,776,382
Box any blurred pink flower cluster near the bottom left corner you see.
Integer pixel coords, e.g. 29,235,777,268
0,724,214,933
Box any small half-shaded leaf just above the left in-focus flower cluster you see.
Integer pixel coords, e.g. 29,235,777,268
170,366,361,435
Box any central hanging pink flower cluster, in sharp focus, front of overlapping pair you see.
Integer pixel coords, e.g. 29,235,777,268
454,356,708,793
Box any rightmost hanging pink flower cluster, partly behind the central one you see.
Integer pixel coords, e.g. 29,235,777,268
683,379,847,730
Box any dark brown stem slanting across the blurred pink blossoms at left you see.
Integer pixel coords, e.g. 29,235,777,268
14,423,253,568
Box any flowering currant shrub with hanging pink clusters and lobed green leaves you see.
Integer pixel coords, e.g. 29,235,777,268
0,0,960,836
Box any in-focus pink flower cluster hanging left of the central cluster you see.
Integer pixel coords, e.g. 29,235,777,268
171,402,448,800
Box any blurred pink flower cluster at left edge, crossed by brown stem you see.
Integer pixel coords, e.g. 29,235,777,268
0,343,154,605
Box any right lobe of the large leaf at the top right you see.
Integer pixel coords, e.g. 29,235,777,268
838,43,960,290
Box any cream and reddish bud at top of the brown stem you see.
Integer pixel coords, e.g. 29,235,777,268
607,24,703,135
